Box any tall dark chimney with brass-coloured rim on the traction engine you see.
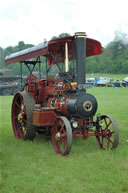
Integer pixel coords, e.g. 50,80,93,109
74,32,86,90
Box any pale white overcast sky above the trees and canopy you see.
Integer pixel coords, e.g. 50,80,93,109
0,0,128,48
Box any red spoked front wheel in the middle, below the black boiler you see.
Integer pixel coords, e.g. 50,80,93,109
52,116,72,155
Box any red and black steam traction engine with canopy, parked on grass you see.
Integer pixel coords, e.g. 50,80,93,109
5,32,119,155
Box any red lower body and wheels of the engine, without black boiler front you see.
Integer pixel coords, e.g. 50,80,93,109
12,76,119,155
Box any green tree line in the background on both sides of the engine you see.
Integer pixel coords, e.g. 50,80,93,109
0,32,128,74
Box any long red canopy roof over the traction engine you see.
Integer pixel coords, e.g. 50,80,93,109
5,36,102,64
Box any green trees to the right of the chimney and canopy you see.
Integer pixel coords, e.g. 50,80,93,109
87,33,128,74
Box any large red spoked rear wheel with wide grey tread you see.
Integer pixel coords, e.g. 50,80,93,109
12,92,36,140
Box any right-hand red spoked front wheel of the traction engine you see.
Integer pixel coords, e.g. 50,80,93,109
96,115,119,149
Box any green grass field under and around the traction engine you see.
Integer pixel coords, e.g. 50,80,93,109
0,87,128,193
